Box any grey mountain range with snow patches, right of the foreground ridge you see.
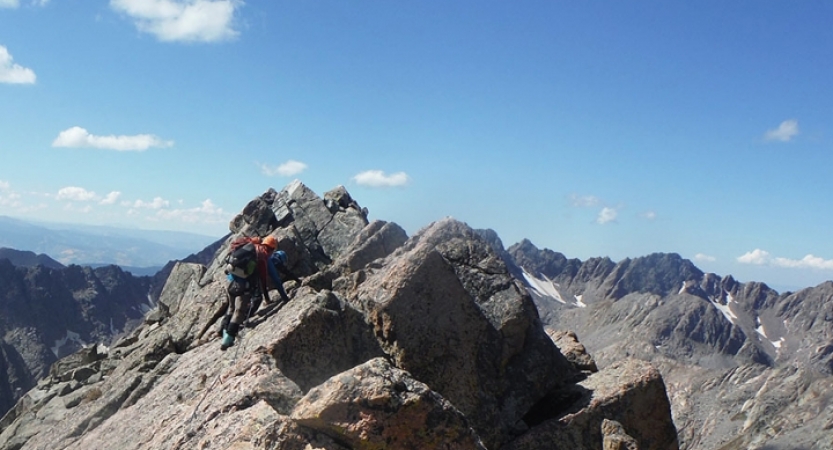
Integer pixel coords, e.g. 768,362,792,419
505,241,833,450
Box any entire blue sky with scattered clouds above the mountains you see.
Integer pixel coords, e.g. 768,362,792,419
0,0,833,289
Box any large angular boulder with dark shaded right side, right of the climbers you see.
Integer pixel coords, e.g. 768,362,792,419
349,219,574,448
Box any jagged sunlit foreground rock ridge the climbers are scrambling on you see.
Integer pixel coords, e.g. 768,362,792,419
0,182,677,450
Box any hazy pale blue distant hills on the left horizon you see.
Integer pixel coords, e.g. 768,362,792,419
0,216,220,275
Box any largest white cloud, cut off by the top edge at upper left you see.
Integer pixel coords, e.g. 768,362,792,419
110,0,243,42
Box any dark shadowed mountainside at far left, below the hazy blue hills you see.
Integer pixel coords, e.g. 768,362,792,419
0,259,150,420
